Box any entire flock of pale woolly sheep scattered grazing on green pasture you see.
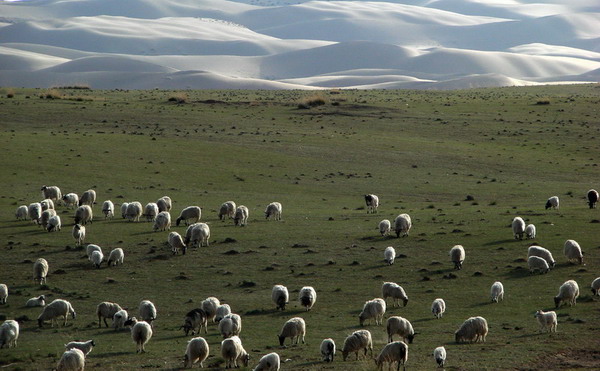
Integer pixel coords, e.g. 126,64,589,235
0,186,600,370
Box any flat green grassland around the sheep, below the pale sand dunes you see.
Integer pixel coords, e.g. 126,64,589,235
0,85,600,370
